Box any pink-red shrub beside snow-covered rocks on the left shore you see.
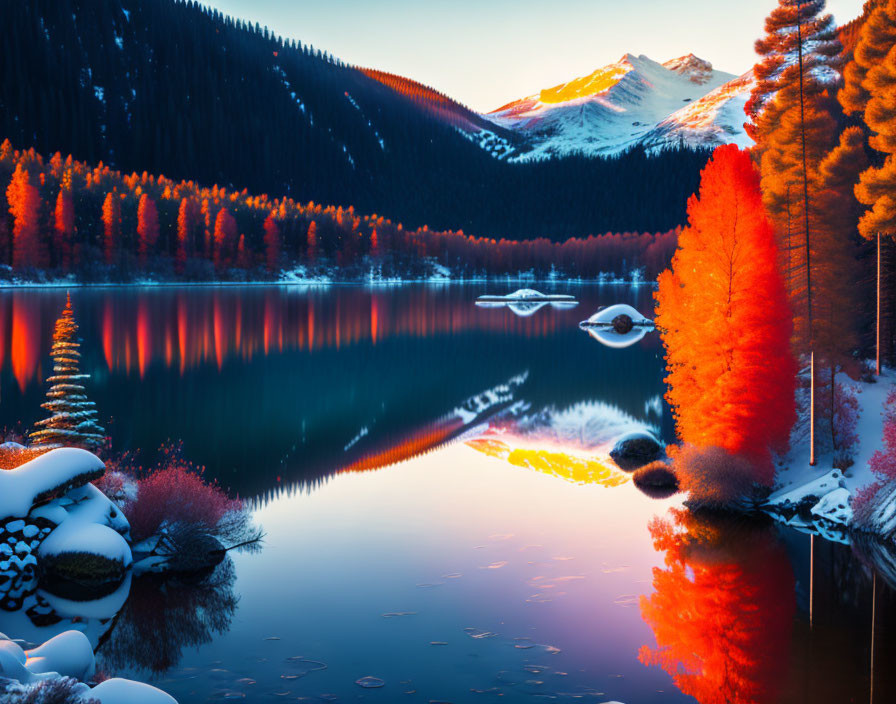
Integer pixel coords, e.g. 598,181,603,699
123,446,243,540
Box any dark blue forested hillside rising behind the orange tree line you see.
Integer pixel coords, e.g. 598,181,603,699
0,0,706,239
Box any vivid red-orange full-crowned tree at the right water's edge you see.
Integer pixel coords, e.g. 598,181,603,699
655,145,796,485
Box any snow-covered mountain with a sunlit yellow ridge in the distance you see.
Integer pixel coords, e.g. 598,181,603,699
486,54,752,159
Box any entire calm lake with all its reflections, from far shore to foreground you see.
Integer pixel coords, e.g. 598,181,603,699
0,284,896,704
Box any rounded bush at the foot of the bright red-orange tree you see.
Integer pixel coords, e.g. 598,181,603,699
672,445,756,508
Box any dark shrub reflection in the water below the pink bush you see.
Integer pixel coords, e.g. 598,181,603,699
97,558,238,674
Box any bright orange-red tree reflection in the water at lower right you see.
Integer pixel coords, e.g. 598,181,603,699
639,510,795,704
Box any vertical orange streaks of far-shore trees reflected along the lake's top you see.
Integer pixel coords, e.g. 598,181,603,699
0,288,608,390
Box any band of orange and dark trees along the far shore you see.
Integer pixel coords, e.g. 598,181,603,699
0,140,677,281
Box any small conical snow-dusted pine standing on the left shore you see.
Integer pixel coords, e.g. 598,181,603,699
31,296,105,450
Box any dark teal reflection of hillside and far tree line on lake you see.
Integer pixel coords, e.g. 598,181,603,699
0,286,671,499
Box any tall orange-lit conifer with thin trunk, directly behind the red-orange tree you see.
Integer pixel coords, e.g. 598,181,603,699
746,0,842,465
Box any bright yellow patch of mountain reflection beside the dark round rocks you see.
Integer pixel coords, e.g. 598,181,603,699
467,438,629,487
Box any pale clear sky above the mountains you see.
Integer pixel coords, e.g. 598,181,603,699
207,0,863,111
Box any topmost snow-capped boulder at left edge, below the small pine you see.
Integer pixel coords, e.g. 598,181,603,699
0,447,105,518
